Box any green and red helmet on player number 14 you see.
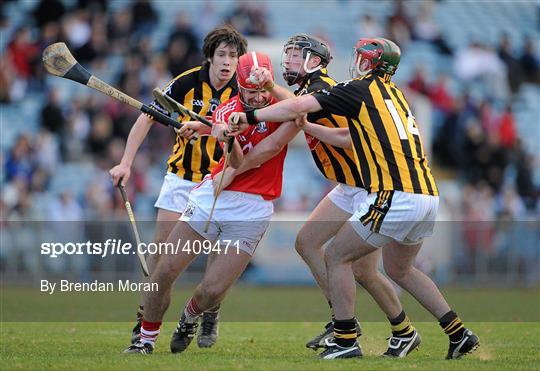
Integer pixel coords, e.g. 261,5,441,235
349,38,401,77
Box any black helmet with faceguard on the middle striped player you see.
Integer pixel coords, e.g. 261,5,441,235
281,34,332,86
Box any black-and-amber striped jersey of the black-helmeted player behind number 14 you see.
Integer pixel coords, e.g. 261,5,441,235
294,68,363,188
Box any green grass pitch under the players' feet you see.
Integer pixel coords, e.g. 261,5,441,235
0,287,540,370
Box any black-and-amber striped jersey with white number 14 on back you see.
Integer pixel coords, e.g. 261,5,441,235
313,74,438,196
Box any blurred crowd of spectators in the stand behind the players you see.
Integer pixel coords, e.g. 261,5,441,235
0,0,540,227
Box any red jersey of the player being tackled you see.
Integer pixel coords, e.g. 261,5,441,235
212,95,287,200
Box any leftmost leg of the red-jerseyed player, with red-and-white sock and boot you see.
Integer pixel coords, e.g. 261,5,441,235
125,221,204,353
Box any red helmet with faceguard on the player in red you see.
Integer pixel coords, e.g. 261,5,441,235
236,52,274,109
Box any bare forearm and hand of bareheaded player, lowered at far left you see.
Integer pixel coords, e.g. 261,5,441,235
109,114,154,185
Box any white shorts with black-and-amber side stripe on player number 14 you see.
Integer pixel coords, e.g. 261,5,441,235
349,191,439,247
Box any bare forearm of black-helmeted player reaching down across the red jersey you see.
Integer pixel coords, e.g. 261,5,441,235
235,121,300,175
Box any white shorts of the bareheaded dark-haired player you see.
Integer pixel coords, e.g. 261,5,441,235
154,172,198,214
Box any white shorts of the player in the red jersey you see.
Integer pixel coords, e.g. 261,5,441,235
180,177,274,255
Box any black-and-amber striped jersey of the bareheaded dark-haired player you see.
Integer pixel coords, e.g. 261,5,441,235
152,64,238,182
